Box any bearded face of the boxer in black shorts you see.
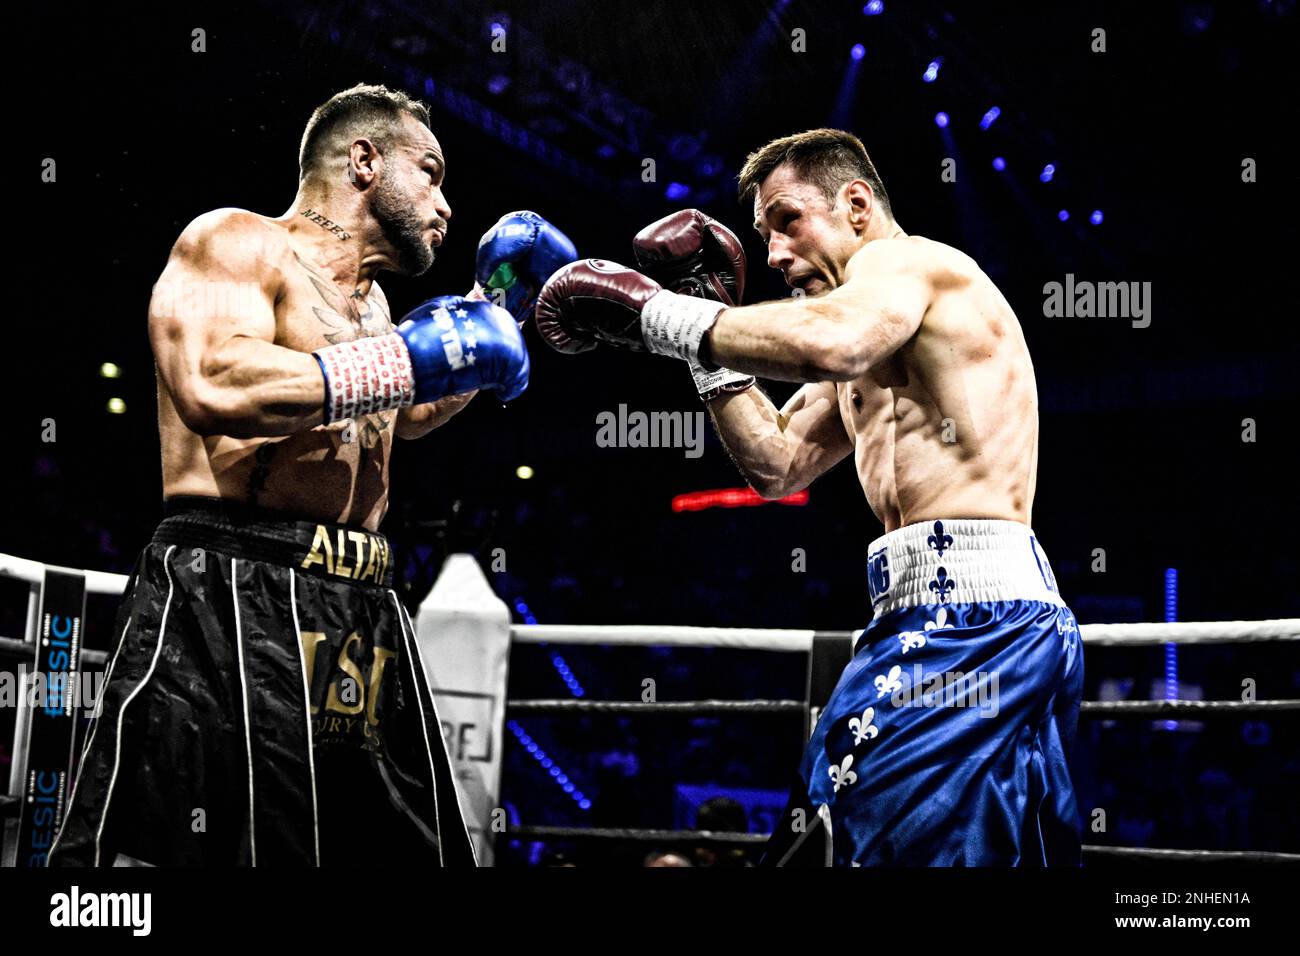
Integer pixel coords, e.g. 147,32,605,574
371,116,451,276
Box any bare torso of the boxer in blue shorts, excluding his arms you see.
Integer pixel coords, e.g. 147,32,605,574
836,237,1039,531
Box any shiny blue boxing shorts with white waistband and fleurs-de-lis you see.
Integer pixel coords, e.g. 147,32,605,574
763,519,1083,866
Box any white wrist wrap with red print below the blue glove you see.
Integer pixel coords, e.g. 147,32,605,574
312,332,415,424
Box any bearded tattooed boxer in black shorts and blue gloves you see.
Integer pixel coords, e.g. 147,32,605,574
49,86,575,866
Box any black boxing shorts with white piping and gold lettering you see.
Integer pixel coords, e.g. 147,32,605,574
49,498,476,866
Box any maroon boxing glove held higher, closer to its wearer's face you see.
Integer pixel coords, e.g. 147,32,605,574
632,209,745,306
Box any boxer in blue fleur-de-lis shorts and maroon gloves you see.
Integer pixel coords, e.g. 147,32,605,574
536,129,1083,866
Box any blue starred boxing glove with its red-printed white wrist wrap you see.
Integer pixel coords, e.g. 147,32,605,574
312,295,529,424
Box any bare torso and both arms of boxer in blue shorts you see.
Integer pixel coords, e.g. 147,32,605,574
710,235,1039,531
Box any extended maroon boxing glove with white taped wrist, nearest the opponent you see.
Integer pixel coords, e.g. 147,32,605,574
536,259,725,362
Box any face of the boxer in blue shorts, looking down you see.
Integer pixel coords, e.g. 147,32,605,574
754,165,862,295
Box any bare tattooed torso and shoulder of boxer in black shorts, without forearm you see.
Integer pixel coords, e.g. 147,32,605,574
150,209,468,531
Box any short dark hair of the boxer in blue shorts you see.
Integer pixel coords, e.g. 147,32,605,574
740,129,893,217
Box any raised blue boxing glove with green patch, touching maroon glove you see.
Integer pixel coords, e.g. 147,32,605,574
475,209,577,323
